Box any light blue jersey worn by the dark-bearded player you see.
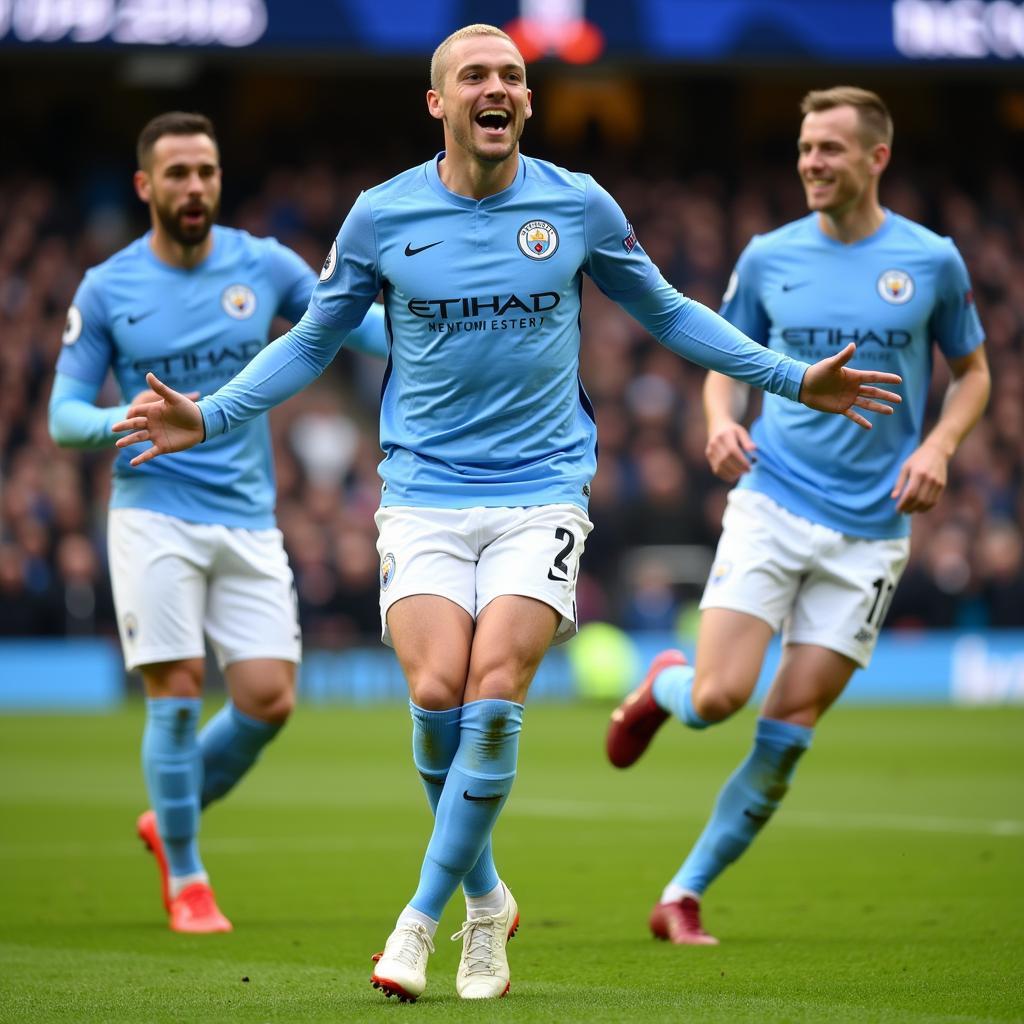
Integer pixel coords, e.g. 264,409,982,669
50,226,386,529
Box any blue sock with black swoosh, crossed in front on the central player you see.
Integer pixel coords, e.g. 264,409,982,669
410,700,522,921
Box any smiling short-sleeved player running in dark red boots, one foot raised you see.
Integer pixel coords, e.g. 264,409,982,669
607,87,989,945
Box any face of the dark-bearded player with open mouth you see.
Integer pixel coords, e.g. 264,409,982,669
136,135,220,246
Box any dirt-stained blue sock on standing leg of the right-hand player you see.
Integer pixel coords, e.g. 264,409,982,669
672,718,814,896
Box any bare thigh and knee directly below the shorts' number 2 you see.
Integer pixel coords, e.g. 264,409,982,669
466,594,564,703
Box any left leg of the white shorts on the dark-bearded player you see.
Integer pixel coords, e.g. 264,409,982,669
106,508,212,669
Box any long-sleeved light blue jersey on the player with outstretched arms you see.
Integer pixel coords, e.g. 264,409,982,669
200,154,807,508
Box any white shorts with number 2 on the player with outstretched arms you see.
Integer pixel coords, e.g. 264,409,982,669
376,505,594,646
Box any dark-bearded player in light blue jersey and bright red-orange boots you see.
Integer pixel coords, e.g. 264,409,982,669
50,113,387,933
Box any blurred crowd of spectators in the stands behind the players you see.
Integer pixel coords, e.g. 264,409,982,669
0,149,1024,647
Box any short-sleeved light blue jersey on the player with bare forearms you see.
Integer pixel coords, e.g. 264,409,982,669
721,210,984,539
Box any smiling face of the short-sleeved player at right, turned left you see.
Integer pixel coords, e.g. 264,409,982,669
797,106,888,216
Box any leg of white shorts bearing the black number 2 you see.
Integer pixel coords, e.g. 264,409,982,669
474,504,594,650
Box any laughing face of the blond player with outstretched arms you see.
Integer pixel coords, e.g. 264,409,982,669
427,36,534,164
